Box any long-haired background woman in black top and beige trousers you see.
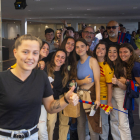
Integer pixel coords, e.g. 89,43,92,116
47,49,68,140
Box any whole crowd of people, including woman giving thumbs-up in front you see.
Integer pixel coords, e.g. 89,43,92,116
0,20,140,140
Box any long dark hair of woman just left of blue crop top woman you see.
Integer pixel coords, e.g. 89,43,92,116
60,36,77,80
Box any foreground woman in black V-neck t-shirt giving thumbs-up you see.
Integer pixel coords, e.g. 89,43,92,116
0,35,78,140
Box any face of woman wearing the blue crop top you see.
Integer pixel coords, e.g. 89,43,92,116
76,41,89,56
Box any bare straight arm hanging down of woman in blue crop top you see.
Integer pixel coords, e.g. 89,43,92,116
90,58,100,108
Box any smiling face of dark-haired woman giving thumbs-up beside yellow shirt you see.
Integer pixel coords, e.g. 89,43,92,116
108,47,118,61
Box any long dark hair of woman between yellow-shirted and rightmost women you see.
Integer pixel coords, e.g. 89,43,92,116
107,44,125,78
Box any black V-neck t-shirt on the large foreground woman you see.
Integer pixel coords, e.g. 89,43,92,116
0,69,53,130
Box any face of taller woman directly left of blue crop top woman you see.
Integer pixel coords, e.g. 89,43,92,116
65,38,75,54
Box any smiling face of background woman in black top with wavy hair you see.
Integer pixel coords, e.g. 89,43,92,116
54,51,66,68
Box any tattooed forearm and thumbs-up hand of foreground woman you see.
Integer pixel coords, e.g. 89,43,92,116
43,86,79,113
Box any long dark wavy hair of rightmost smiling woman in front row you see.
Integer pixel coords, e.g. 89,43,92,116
120,43,140,80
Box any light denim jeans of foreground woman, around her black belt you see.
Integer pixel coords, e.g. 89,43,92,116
0,126,38,140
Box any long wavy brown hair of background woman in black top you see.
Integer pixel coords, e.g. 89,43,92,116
47,49,69,87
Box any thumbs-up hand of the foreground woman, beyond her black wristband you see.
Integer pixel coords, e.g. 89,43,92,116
65,86,79,106
